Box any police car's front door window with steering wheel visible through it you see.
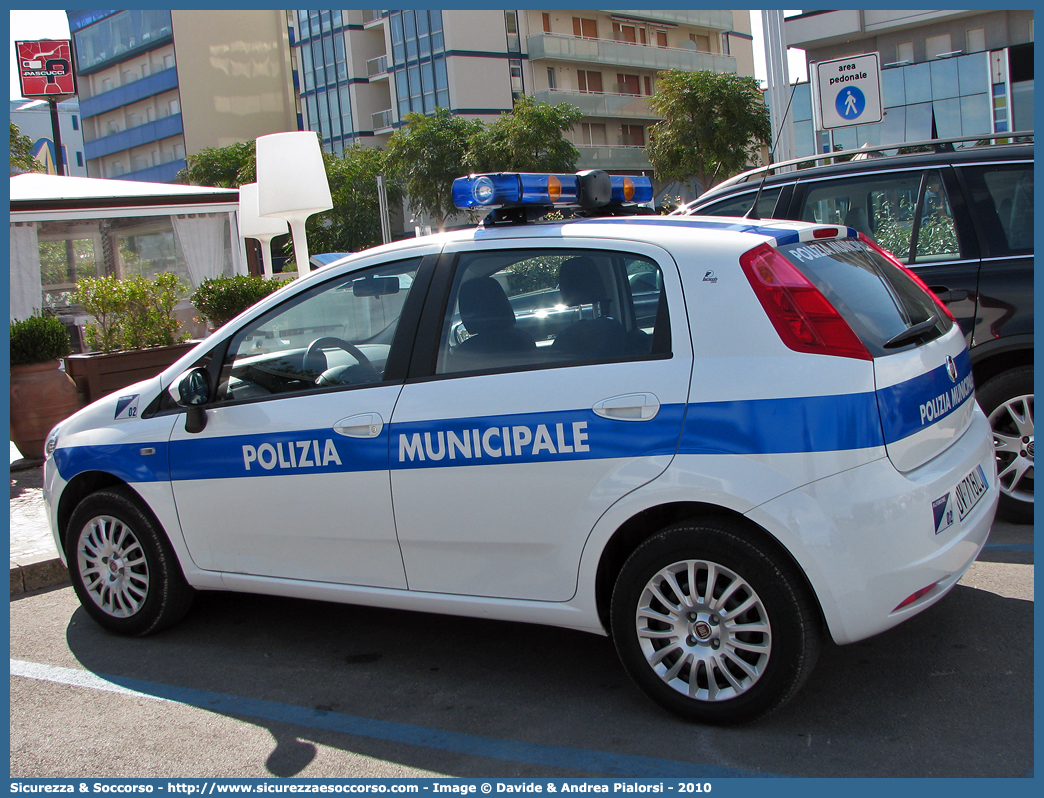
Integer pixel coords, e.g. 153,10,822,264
218,259,420,401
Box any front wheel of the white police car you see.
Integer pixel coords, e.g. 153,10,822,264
66,488,195,637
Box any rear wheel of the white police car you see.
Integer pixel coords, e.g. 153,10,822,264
610,518,822,725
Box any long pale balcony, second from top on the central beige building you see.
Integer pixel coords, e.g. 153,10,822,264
526,33,736,73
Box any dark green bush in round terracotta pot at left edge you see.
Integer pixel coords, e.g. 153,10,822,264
10,315,80,459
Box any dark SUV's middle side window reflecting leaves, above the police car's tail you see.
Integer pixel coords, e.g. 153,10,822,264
801,170,960,264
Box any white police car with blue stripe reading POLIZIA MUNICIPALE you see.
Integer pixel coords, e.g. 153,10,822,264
45,172,998,723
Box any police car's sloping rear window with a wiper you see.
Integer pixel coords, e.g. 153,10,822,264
779,238,953,357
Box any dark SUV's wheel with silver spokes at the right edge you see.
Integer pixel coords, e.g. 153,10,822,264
976,366,1034,523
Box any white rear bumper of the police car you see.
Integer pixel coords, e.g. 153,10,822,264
746,404,1000,643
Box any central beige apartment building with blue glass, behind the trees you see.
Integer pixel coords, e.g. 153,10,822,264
287,9,754,171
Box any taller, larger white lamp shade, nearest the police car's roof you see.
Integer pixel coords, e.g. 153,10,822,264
257,131,333,219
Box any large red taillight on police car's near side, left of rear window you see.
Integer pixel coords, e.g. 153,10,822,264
739,243,873,360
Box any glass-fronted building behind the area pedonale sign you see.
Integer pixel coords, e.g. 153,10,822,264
784,9,1034,156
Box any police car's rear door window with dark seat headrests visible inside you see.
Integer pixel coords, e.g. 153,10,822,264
437,250,670,374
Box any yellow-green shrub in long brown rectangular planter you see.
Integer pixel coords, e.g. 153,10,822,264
66,273,195,402
